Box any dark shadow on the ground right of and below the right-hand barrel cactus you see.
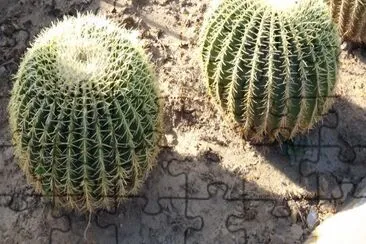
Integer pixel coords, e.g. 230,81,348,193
253,98,366,201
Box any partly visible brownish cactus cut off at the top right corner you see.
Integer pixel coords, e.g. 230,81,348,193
327,0,366,44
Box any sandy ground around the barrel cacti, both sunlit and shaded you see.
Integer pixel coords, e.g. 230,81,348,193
0,0,366,243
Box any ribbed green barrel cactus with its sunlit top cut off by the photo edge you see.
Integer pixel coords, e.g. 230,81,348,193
201,0,340,141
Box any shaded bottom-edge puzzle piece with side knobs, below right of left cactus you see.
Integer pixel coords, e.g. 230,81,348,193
97,198,202,244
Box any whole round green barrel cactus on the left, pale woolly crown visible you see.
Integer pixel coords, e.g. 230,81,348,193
8,15,161,211
